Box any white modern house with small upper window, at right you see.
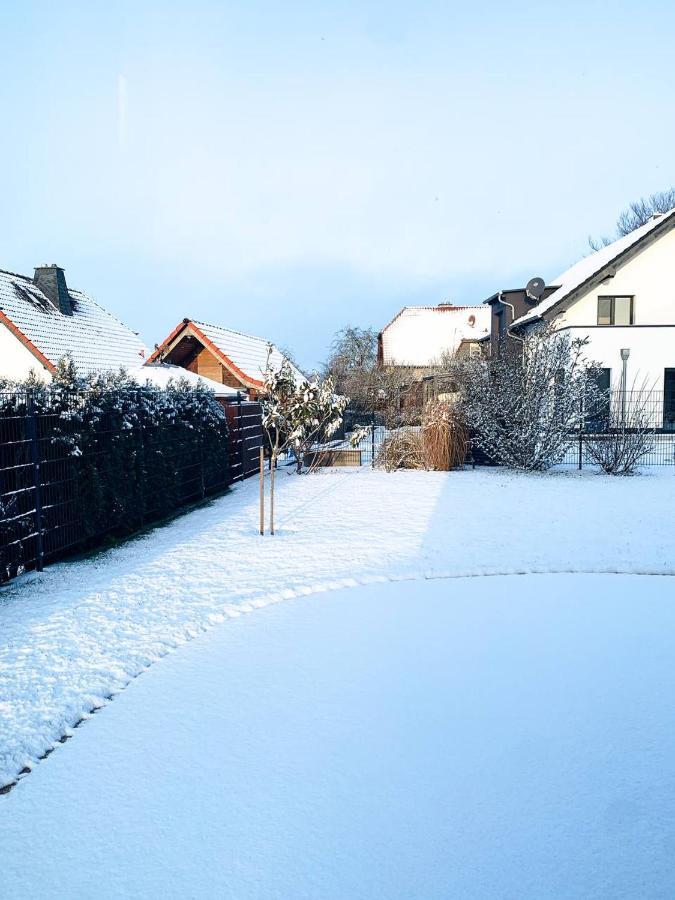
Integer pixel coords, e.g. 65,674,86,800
485,209,675,427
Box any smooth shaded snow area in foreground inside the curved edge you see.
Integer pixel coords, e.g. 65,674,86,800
0,576,675,900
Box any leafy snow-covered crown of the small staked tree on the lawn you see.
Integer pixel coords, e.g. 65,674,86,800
261,362,347,473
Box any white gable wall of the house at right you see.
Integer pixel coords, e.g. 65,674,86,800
555,230,675,391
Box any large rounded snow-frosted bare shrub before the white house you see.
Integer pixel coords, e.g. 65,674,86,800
461,326,596,470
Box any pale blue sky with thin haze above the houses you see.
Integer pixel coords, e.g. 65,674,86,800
0,0,675,367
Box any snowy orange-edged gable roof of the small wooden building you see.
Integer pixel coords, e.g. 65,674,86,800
149,319,305,388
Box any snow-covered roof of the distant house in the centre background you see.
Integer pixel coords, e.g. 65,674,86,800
382,305,490,366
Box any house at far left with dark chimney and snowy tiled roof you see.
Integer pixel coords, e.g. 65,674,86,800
0,265,146,381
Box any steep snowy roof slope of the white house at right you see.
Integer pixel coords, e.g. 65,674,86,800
511,209,675,327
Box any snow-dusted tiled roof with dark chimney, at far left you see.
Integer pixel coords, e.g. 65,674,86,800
0,271,146,374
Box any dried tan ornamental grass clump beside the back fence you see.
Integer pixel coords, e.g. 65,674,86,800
375,400,468,472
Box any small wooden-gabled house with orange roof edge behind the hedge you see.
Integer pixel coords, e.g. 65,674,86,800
149,319,305,399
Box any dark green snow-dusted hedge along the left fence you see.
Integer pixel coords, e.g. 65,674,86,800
0,360,230,580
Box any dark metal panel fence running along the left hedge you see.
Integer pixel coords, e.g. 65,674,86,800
0,391,262,583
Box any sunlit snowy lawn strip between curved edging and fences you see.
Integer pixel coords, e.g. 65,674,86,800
0,469,675,796
